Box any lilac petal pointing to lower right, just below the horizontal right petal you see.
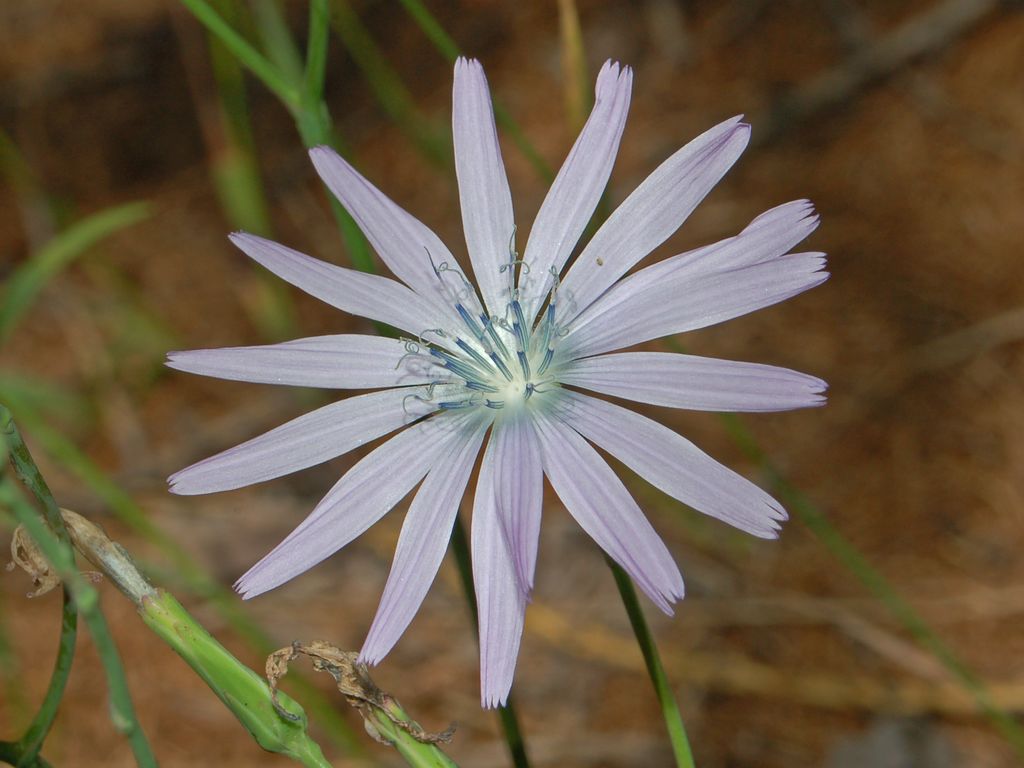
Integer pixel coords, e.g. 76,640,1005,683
562,392,786,539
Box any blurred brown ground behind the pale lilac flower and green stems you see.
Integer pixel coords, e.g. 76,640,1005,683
0,0,1024,768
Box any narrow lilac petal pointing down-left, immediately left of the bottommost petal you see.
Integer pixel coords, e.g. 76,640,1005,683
359,415,487,664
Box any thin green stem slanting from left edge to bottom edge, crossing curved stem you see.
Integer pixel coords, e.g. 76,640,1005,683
0,476,157,768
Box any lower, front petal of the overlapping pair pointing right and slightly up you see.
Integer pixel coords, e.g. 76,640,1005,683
562,253,828,357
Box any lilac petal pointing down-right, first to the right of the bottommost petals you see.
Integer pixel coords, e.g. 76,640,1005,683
536,417,683,615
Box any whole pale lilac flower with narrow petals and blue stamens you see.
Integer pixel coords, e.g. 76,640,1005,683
168,58,827,707
